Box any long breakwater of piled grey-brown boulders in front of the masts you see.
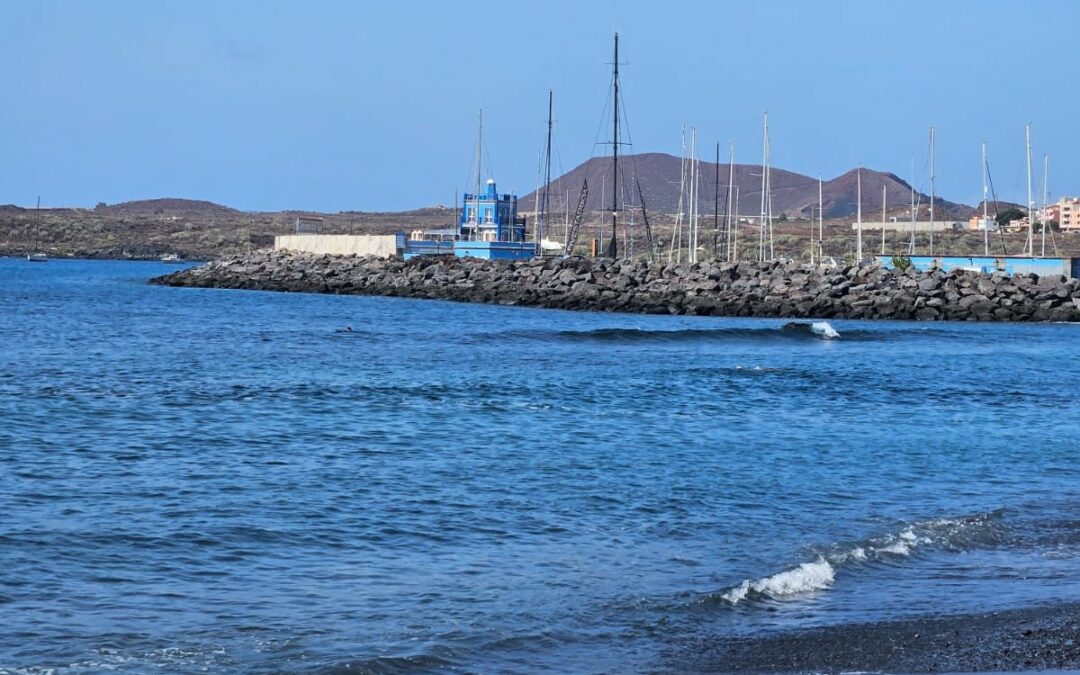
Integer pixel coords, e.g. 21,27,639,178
153,252,1080,321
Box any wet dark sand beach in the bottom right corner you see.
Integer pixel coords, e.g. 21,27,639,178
667,603,1080,673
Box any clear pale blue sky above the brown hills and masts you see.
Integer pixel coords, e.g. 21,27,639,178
0,0,1080,212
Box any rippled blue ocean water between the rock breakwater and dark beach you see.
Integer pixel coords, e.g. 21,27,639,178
0,254,1080,673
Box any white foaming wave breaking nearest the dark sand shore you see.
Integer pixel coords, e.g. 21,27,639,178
701,511,1002,605
